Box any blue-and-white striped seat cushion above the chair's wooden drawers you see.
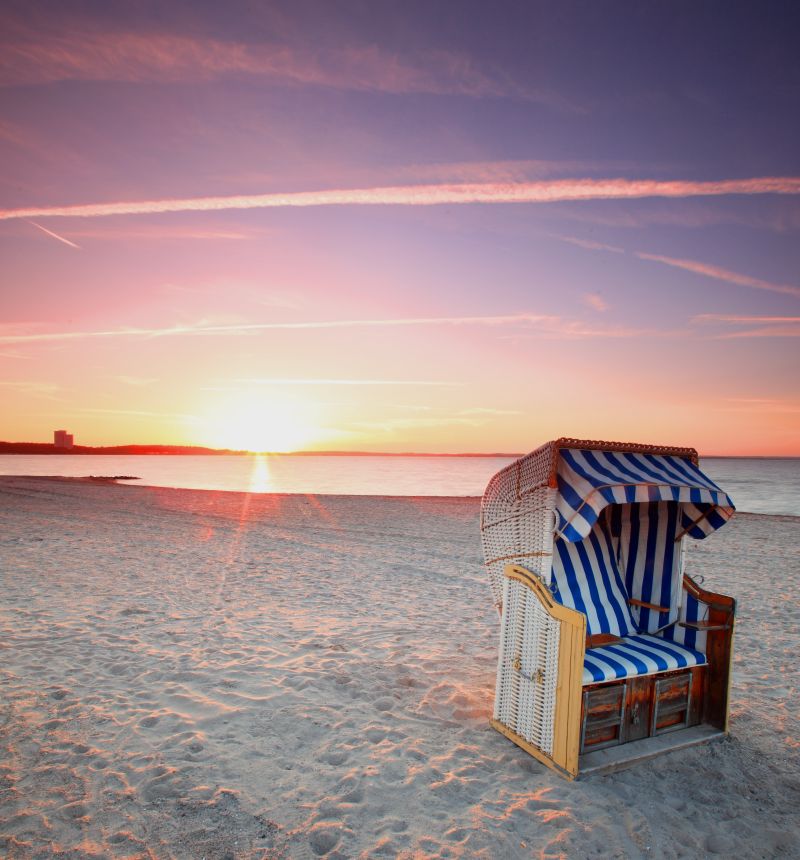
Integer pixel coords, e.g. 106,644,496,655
583,634,706,686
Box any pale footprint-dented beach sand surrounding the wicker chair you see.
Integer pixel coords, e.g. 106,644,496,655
0,478,800,860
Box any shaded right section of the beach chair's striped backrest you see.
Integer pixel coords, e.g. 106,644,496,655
607,502,683,633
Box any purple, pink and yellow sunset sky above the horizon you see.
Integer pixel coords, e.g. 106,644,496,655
0,0,800,456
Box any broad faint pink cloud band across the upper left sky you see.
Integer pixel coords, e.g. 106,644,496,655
0,26,540,101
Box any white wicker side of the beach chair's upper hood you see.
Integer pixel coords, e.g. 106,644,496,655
481,484,556,606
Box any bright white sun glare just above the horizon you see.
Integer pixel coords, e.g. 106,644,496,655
196,391,320,452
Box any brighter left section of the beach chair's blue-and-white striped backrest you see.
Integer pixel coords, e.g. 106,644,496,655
550,512,636,636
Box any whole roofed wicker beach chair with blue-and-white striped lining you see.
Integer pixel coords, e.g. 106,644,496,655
481,439,735,778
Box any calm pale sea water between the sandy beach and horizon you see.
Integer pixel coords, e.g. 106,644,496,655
0,454,800,516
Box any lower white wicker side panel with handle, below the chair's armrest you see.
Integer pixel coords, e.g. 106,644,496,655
494,579,561,756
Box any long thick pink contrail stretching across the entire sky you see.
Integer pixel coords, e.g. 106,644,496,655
0,176,800,220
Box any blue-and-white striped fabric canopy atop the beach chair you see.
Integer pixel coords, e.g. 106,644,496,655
556,448,734,542
